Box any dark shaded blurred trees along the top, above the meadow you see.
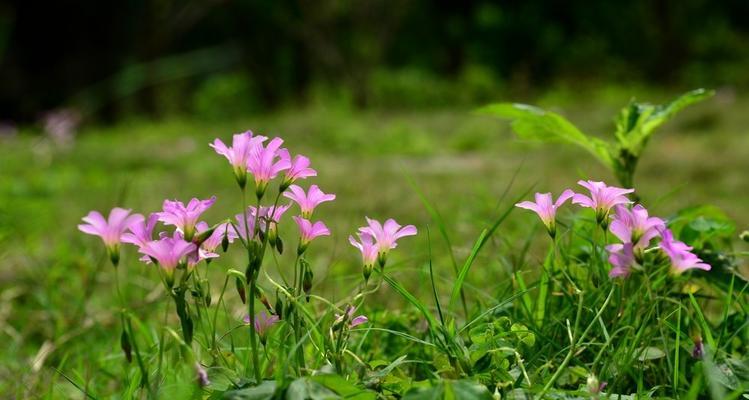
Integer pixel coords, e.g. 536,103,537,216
0,0,749,123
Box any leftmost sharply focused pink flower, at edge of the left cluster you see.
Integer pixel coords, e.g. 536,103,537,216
78,207,143,267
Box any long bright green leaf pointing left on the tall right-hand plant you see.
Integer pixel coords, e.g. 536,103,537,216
478,103,614,168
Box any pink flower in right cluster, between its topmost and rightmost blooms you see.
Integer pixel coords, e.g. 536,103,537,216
609,204,666,250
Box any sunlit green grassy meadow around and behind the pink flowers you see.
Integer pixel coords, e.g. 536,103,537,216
0,88,749,399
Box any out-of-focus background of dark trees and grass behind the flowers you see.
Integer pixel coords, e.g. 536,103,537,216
0,0,749,397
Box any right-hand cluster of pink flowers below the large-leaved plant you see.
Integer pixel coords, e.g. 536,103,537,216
516,181,710,278
